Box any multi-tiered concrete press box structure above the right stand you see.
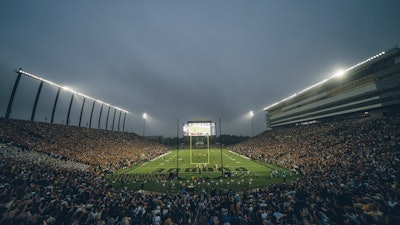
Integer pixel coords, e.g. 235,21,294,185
264,46,400,129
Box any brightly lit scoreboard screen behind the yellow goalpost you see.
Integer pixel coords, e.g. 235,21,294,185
183,121,216,136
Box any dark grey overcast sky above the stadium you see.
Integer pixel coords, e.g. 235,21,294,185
0,0,400,137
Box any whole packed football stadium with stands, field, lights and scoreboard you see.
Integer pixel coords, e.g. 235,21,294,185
0,47,400,225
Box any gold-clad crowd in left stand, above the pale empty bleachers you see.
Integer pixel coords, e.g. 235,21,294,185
0,119,167,171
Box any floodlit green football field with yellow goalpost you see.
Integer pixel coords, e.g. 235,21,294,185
107,149,297,192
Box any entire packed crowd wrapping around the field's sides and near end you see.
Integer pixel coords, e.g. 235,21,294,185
0,114,400,225
